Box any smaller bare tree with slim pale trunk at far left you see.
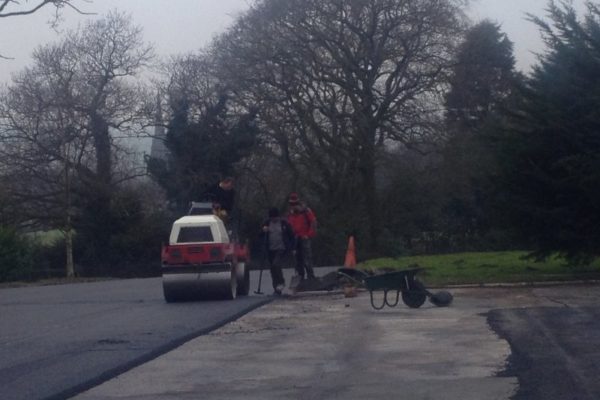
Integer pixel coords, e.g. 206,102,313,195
0,96,91,277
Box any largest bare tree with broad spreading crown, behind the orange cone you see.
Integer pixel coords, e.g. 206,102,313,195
215,0,462,253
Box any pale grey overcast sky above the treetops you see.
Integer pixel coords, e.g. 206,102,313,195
0,0,583,82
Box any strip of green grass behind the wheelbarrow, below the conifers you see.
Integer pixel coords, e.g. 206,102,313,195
358,251,600,285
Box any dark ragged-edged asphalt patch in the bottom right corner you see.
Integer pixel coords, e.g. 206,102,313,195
487,305,600,400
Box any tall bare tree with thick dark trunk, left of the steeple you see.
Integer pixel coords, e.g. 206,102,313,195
66,12,153,260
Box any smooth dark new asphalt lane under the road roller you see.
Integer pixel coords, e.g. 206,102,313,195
0,274,270,400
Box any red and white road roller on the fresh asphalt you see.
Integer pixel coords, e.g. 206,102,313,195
161,215,250,303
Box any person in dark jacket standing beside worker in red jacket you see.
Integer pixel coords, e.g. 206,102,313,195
262,207,294,295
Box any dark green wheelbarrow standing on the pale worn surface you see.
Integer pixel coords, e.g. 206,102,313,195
338,268,452,310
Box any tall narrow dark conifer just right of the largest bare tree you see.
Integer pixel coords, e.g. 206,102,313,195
438,20,519,251
